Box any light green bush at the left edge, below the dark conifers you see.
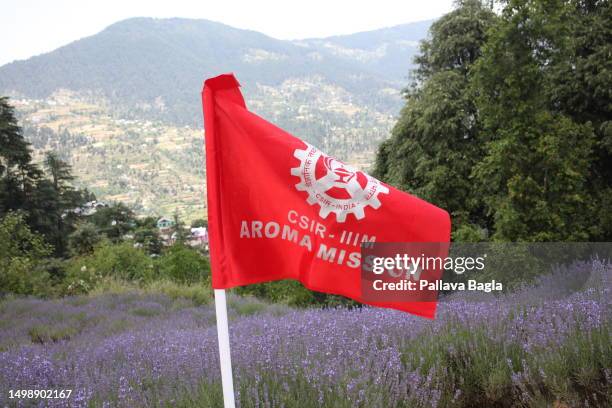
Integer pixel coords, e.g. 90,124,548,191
0,212,51,295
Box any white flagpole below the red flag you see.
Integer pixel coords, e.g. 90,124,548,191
215,289,236,408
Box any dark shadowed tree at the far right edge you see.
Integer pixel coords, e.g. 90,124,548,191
546,0,612,241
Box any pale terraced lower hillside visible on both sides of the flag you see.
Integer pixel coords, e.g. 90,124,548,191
11,77,394,220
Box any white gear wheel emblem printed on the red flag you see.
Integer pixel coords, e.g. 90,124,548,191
291,143,389,222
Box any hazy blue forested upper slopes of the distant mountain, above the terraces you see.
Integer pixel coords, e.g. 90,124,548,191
0,18,429,124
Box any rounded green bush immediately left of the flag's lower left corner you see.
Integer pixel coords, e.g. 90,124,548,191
159,242,210,283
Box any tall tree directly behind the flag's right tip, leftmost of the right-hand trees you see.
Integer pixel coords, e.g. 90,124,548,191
374,0,496,240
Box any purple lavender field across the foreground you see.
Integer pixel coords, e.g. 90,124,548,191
0,261,612,407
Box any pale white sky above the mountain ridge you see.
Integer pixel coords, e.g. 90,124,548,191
0,0,453,65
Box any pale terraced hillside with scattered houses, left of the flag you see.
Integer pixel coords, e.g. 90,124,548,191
12,91,206,219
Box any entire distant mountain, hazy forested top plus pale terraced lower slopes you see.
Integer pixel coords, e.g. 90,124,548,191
0,18,430,218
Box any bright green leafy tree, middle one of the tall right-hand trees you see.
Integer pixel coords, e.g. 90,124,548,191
473,0,599,241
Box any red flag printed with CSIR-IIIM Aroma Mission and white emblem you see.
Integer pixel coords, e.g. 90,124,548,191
202,74,450,317
